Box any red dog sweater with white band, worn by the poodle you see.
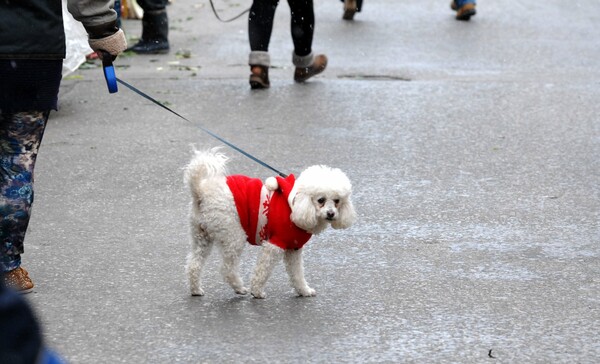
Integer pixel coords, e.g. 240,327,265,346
227,175,312,249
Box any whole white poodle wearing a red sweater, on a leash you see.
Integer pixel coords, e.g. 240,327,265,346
185,149,356,298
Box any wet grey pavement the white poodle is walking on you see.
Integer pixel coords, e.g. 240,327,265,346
23,0,600,363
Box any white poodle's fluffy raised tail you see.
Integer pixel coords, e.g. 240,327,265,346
183,148,229,200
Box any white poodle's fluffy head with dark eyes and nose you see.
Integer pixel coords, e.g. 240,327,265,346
288,166,356,234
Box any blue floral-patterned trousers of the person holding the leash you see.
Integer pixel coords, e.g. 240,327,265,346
0,111,48,272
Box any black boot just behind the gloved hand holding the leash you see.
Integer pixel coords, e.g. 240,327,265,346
127,9,169,54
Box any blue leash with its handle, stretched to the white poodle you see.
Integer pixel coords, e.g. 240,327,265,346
102,52,287,178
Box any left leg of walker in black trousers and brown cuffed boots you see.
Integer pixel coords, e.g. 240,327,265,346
248,0,279,89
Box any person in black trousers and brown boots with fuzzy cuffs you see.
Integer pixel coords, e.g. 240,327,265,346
248,0,327,89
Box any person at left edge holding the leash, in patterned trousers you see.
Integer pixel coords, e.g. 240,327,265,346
0,0,127,293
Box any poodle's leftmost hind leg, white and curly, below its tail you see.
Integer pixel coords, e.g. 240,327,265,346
185,227,213,296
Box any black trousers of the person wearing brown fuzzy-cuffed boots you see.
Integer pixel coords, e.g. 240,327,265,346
248,0,315,56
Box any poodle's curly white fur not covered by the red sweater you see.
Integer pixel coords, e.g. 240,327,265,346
184,149,356,298
